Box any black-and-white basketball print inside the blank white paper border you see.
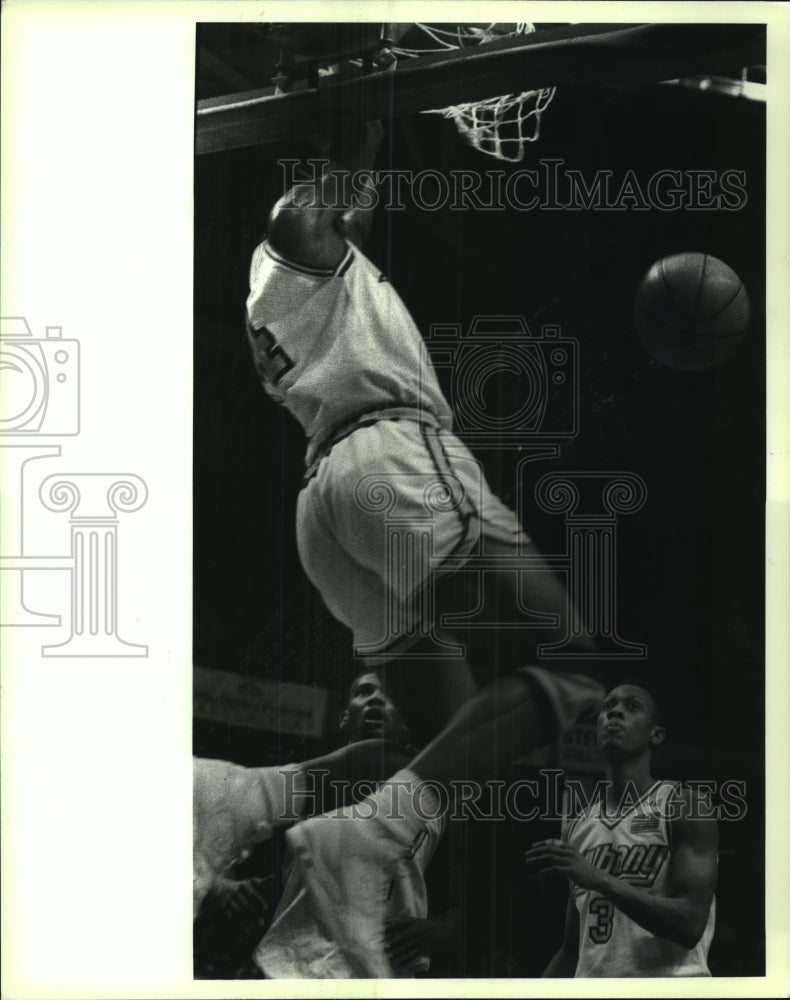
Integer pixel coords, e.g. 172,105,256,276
193,8,766,979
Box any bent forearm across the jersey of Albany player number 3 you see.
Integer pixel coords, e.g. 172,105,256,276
590,872,707,948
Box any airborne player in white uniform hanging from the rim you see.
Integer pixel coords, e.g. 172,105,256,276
247,124,602,743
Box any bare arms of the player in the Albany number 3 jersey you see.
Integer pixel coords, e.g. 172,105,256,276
526,789,718,976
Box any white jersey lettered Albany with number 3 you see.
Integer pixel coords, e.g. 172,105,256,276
563,781,716,978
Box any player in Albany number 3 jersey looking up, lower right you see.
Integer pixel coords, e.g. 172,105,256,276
525,684,718,978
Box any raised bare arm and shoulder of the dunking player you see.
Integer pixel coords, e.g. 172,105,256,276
267,122,383,268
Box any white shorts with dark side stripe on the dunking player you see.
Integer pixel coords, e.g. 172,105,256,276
296,415,529,655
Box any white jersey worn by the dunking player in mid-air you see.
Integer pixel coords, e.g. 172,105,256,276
247,243,452,465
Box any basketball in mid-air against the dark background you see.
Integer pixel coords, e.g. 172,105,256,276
634,253,749,372
